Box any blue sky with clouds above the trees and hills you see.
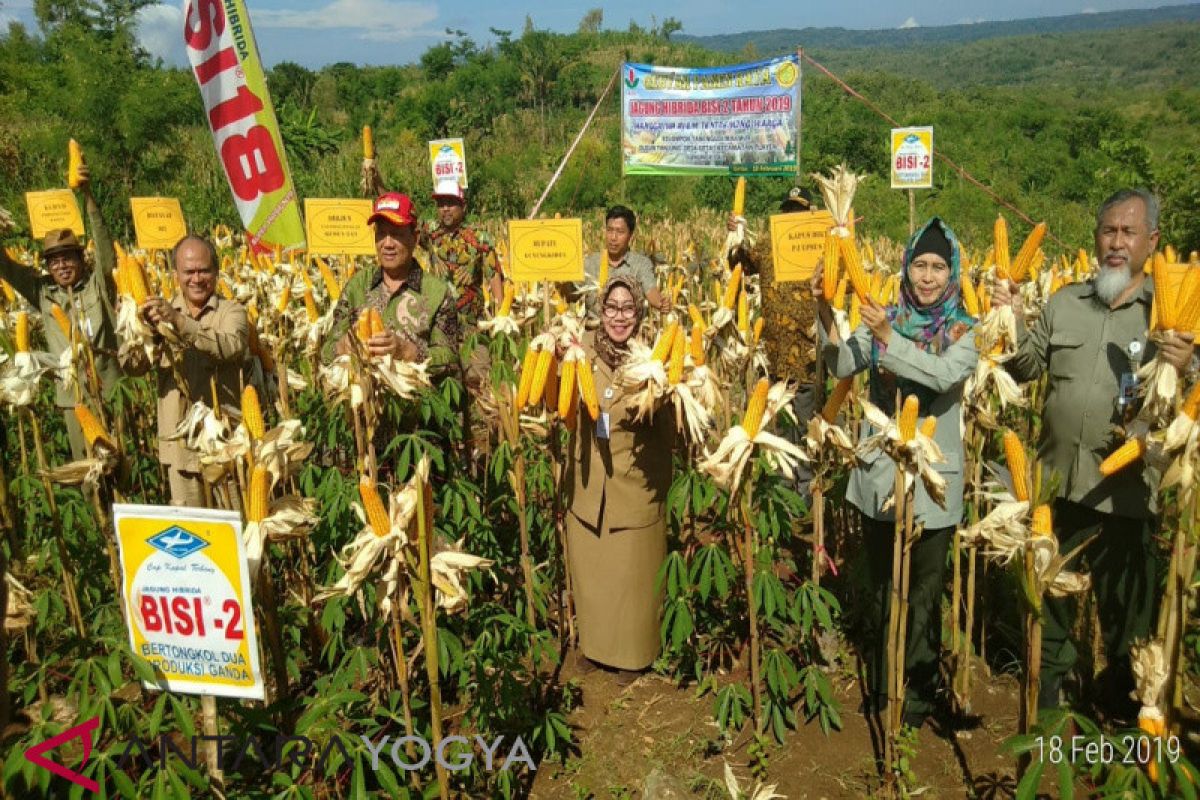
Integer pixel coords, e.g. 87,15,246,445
0,0,1177,67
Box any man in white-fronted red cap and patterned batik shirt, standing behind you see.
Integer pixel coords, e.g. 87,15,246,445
418,178,504,391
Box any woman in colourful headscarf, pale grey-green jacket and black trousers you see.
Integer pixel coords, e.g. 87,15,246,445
812,217,979,727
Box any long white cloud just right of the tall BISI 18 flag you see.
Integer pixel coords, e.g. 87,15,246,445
251,0,440,42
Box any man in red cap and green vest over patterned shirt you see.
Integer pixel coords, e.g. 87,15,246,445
323,192,458,373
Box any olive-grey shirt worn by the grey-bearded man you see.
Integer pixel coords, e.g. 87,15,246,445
1004,277,1158,519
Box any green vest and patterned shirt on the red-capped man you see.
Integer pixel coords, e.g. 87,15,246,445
322,261,458,374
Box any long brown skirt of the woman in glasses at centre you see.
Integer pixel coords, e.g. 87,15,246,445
566,513,667,669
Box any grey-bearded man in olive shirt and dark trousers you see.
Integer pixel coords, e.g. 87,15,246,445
992,190,1193,722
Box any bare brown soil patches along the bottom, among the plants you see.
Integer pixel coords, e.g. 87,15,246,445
532,673,1019,800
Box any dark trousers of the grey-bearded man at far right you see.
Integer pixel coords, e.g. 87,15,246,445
1038,500,1160,708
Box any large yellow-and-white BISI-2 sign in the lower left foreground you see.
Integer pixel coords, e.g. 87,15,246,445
113,504,264,699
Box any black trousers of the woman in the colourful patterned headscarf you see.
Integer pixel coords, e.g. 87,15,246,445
862,515,954,714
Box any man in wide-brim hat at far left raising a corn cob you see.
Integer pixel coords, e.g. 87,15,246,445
0,167,120,459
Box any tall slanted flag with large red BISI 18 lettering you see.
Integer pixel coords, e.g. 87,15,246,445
184,0,305,248
